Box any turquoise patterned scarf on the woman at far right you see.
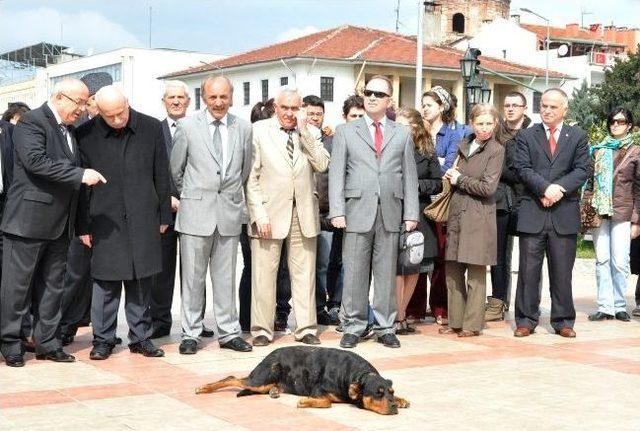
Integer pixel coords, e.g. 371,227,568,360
589,134,632,216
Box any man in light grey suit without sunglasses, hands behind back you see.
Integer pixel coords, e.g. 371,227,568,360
171,76,252,355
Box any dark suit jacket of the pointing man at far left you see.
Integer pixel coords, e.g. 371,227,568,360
0,103,84,240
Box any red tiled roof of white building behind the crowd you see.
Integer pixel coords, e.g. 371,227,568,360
163,25,566,78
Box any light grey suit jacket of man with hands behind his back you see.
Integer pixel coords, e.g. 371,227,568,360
171,110,251,236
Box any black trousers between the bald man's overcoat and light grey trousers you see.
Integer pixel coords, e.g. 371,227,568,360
151,225,178,331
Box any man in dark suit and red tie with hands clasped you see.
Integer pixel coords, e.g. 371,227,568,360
514,88,589,338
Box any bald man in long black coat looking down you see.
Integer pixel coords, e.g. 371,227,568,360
78,85,171,360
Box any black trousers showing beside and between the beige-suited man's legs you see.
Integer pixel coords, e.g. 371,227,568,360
238,225,291,331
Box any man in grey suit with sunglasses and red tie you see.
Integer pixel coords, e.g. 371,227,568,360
329,75,419,348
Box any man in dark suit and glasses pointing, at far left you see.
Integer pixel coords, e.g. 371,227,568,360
0,78,105,367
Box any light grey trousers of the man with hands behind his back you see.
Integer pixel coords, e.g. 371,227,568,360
180,229,241,344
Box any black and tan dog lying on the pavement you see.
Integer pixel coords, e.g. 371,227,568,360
196,346,409,415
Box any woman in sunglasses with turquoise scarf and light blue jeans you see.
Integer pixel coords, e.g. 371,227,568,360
588,107,640,322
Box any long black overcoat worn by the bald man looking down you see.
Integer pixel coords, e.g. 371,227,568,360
78,109,172,280
